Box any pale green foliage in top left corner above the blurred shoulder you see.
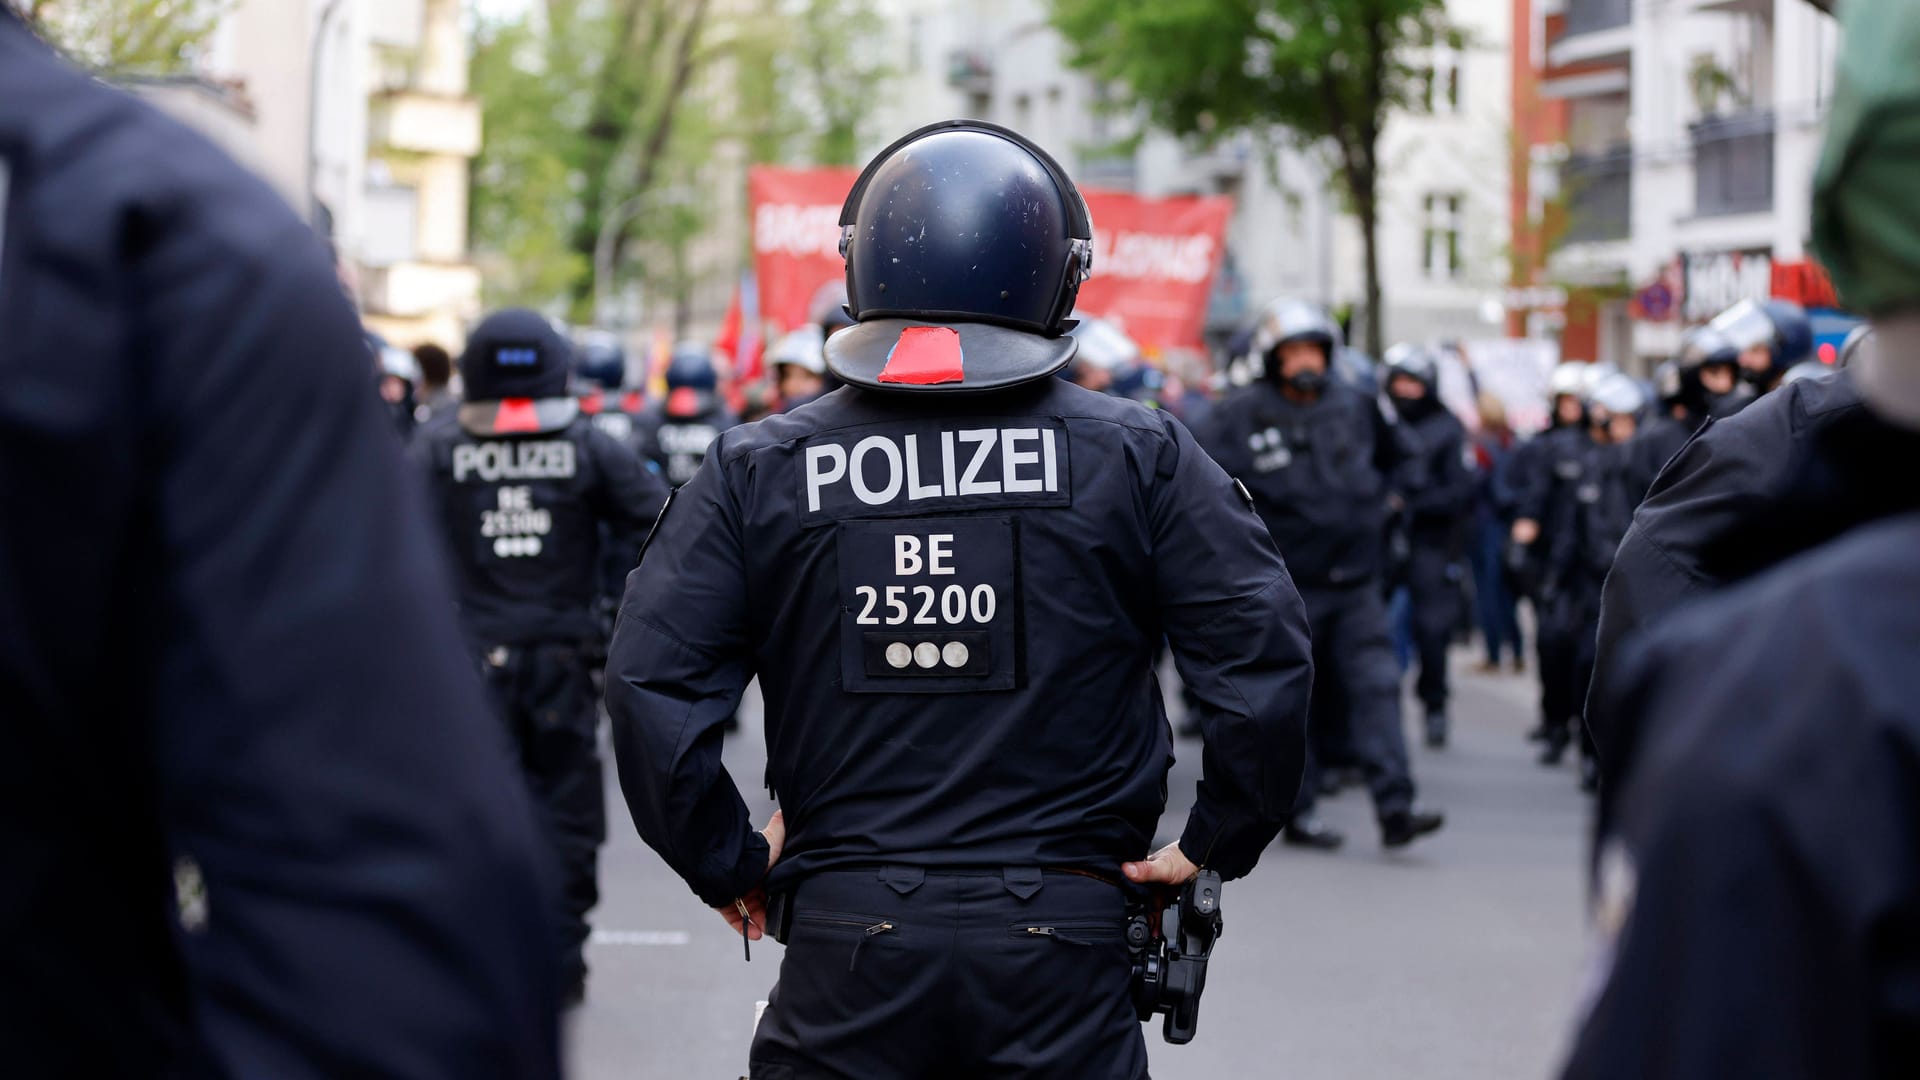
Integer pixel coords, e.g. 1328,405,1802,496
22,0,232,75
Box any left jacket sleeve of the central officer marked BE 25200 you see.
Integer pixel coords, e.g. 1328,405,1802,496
607,436,768,907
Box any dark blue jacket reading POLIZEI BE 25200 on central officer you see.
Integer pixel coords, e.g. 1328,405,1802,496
607,379,1311,905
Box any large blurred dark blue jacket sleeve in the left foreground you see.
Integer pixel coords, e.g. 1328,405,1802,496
140,220,559,1080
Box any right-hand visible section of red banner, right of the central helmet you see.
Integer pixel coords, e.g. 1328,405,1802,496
1073,190,1233,348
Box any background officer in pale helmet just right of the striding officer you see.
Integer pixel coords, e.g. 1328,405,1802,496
1386,346,1475,746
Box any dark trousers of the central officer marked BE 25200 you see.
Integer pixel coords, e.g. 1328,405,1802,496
749,865,1146,1080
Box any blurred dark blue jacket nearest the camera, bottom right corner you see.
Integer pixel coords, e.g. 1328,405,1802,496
1565,515,1920,1080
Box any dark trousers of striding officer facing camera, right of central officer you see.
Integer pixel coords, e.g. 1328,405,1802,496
1294,580,1413,817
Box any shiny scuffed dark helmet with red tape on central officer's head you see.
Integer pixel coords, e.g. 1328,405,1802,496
828,119,1092,390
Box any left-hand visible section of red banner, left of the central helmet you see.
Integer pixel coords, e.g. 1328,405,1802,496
747,165,860,332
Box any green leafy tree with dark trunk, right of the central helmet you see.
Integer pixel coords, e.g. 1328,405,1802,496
1052,0,1461,356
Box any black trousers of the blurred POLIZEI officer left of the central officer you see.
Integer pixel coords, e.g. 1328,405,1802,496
480,642,607,988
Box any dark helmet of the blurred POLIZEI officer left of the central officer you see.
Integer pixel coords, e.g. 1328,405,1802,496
459,307,580,434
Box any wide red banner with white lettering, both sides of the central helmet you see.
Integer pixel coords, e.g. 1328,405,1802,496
747,165,1233,348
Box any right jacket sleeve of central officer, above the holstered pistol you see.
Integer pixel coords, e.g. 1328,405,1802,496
1148,417,1313,878
